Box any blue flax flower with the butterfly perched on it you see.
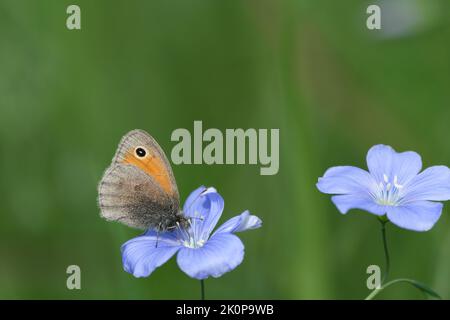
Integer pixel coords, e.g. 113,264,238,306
121,187,261,280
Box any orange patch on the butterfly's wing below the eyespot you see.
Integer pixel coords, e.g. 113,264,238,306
123,152,173,194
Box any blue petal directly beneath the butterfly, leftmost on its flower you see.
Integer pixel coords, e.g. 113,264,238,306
121,232,180,278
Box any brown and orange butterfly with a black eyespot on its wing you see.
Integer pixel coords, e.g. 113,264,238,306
98,129,189,232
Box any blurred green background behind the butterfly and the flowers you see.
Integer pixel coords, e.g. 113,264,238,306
0,0,450,299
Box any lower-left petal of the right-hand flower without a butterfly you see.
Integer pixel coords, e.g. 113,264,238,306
331,194,386,216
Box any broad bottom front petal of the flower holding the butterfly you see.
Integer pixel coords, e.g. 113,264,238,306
177,233,244,280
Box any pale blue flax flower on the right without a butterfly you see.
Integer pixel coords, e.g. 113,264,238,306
317,145,450,231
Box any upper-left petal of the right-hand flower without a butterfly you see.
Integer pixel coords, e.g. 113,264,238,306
317,166,376,194
